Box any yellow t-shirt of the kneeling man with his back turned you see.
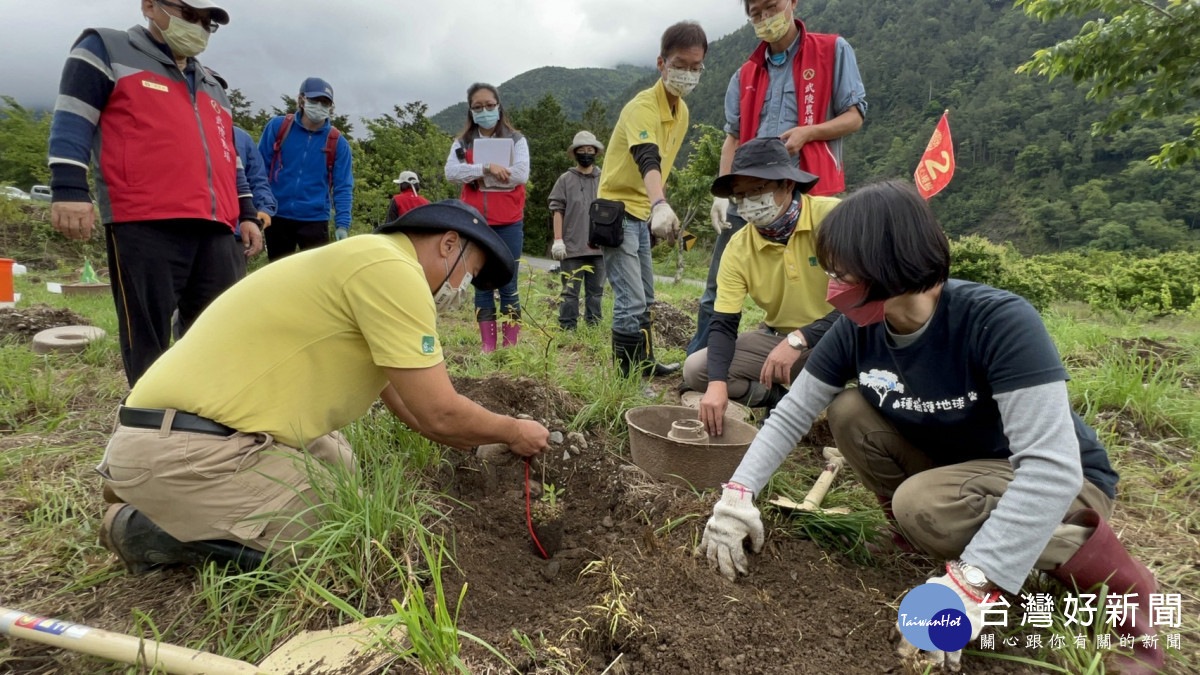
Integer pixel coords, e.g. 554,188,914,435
126,233,442,447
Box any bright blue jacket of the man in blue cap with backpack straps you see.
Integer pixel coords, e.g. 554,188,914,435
258,114,354,228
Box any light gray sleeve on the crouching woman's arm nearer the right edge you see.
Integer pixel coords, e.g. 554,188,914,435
962,381,1084,593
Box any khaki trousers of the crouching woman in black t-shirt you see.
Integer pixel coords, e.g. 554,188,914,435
829,388,1112,569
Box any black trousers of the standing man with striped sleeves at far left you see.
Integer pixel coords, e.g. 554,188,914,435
104,219,241,387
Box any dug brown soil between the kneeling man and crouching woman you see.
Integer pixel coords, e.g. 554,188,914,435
446,378,1032,674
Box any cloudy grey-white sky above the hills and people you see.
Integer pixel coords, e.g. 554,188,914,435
0,0,745,117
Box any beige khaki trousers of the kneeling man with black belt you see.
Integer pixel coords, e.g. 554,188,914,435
96,410,356,551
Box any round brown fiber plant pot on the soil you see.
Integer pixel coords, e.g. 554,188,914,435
625,406,758,489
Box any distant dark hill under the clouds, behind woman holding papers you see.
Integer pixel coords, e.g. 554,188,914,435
430,65,654,135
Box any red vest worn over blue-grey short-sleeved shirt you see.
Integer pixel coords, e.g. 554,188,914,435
738,20,846,196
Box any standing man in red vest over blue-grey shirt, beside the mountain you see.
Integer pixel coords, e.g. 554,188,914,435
688,0,866,356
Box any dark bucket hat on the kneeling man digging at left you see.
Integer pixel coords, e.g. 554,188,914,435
374,199,517,291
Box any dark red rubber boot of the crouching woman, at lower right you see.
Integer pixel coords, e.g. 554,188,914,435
1050,508,1166,675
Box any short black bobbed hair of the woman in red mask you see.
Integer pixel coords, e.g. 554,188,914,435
816,180,950,301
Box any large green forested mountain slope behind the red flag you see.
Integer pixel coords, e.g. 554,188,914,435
434,0,1200,252
